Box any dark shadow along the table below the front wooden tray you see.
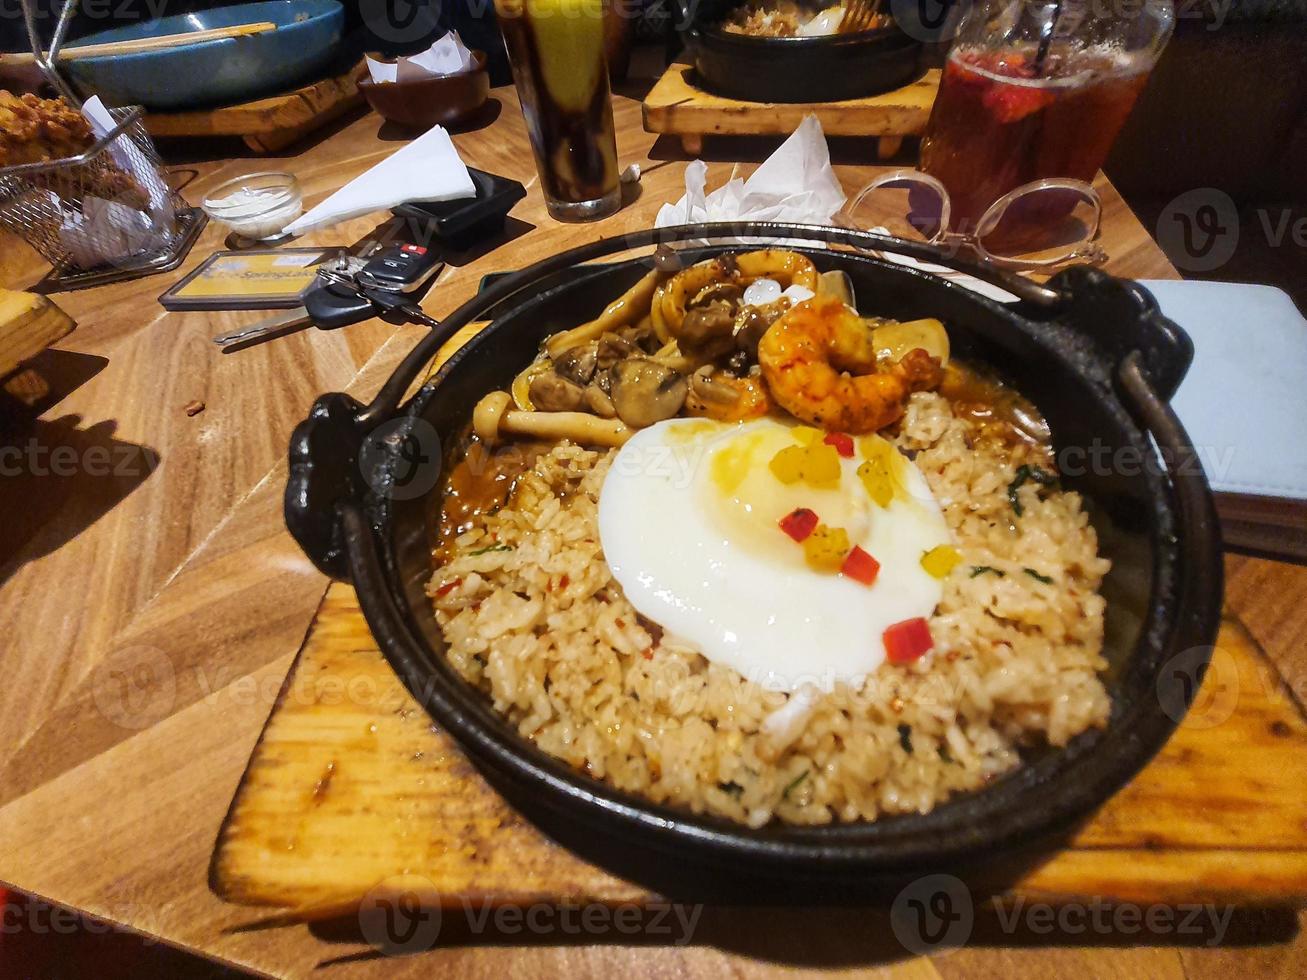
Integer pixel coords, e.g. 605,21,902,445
294,896,1298,968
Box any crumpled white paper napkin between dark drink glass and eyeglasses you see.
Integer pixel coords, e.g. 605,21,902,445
654,115,846,241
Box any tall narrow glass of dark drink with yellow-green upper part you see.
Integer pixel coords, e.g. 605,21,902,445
495,0,622,221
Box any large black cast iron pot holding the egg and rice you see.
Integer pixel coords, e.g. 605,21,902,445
285,223,1222,899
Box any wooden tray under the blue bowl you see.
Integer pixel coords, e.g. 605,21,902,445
145,61,367,153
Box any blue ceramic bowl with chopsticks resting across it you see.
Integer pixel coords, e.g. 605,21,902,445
67,0,345,108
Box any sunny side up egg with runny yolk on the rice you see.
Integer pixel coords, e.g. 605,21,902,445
599,418,949,691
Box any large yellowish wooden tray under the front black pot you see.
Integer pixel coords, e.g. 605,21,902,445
210,583,1307,921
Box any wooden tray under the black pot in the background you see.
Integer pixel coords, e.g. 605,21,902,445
643,64,940,159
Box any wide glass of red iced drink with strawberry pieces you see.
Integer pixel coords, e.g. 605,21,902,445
921,0,1175,239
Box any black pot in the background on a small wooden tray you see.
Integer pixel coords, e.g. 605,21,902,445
680,0,921,102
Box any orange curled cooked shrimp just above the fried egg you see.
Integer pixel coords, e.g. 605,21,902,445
758,298,940,433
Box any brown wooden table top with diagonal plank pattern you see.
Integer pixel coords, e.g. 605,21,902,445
0,78,1307,980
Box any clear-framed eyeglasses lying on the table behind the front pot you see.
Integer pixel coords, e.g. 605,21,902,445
843,170,1107,270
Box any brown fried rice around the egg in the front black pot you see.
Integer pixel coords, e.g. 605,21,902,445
429,392,1110,827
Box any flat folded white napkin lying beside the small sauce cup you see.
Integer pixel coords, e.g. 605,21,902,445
286,125,477,235
